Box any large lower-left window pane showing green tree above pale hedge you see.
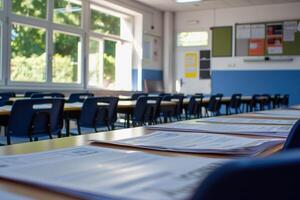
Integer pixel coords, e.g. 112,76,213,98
10,24,46,82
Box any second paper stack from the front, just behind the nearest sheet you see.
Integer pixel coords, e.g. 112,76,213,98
95,131,285,155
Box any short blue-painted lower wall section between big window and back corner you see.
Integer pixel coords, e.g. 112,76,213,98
132,69,163,90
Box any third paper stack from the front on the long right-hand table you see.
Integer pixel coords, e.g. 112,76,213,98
147,121,292,138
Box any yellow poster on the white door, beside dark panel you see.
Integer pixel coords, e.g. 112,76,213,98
184,52,199,78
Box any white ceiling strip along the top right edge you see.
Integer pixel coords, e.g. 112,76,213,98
136,0,300,11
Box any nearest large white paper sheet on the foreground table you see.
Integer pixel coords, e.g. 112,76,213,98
0,146,227,200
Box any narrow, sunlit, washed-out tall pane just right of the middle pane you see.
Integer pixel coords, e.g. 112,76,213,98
89,39,103,87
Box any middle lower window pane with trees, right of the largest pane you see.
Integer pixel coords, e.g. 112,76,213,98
52,32,81,83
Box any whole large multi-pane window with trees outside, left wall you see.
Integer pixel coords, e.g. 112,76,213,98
0,0,137,90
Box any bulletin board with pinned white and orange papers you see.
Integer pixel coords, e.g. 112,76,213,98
235,20,300,56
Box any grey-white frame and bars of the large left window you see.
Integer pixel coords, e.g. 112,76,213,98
0,0,135,91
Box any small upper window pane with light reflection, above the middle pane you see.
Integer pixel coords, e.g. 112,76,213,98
53,0,82,26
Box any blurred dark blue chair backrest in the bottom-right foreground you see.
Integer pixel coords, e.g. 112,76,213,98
191,151,300,200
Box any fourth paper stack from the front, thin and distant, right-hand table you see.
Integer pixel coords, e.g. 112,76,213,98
198,117,297,125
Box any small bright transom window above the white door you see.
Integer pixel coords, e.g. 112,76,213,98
177,31,208,47
